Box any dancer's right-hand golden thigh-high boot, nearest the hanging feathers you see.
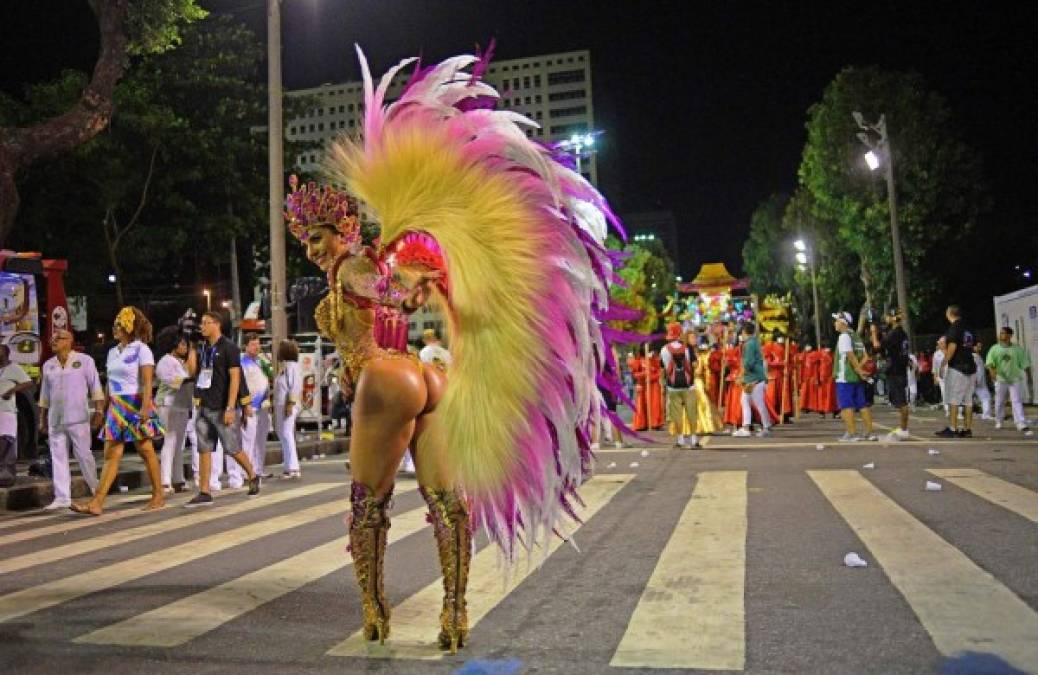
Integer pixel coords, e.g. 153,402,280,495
419,487,472,653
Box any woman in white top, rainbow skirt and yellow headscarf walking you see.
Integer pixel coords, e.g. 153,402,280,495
71,306,165,516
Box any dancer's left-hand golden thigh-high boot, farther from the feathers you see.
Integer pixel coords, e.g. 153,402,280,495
350,481,392,643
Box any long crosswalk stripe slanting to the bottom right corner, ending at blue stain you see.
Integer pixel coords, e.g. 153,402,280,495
808,469,1038,672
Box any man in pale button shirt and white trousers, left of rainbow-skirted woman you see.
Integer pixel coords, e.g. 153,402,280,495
39,329,105,511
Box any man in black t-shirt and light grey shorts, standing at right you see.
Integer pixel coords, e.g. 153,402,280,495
936,304,977,438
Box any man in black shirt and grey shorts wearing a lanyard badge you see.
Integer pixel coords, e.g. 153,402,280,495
184,312,260,508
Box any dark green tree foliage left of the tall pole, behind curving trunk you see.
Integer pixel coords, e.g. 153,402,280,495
10,19,302,315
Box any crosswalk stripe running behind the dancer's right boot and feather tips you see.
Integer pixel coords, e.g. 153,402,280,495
328,467,634,659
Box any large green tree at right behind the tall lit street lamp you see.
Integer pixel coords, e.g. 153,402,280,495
799,68,986,326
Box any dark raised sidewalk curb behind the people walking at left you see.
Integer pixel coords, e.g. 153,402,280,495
0,431,350,513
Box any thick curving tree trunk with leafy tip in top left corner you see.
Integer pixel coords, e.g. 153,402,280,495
0,0,207,245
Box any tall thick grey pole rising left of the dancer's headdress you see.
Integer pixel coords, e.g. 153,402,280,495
267,0,289,357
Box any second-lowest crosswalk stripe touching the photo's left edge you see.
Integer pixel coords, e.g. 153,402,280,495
0,483,343,574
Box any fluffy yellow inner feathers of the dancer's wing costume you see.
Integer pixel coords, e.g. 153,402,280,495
327,123,549,496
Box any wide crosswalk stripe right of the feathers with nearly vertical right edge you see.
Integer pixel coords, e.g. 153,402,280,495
609,471,746,670
